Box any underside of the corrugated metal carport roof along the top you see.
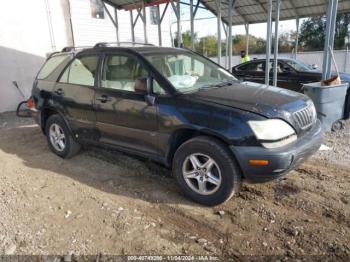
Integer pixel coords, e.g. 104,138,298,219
102,0,350,25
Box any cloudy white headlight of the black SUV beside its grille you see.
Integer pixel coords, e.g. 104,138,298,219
248,119,297,148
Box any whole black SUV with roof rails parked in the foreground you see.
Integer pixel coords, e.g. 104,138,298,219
29,44,321,205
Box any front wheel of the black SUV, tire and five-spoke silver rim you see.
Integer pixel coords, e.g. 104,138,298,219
173,136,241,206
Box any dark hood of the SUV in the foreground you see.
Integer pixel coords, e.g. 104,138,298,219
189,82,309,128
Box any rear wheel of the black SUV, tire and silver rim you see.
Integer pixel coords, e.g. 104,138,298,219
45,114,81,158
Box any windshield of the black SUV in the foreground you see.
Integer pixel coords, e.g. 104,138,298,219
145,52,236,93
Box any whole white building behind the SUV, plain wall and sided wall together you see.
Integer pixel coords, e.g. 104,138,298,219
0,0,171,112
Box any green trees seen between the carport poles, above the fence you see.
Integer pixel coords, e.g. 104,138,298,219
174,13,350,57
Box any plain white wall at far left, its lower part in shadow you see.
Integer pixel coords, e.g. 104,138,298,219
0,0,71,112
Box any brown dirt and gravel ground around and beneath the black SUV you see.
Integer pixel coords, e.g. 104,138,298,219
0,114,350,261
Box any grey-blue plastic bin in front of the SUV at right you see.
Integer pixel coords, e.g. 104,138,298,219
304,82,348,131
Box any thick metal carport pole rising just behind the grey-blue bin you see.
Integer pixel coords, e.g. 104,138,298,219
322,0,338,80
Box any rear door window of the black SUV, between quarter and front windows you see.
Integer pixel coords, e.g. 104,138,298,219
59,55,99,86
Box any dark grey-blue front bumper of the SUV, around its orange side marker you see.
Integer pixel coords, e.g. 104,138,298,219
230,120,322,183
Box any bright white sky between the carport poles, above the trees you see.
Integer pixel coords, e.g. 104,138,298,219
171,1,302,39
